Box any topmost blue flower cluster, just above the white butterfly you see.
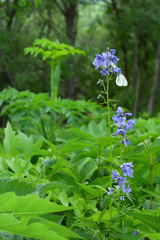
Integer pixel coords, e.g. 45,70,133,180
93,49,122,76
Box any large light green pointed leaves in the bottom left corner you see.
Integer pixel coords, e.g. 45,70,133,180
0,193,82,240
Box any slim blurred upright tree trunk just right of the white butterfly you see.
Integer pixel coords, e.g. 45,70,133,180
133,39,140,117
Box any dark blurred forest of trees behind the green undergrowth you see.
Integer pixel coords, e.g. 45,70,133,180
0,0,160,115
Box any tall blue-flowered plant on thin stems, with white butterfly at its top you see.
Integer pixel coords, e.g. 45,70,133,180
93,49,135,234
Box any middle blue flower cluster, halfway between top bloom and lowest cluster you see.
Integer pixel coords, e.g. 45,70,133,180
112,107,136,146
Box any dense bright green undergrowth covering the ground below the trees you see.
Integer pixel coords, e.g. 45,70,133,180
0,89,160,240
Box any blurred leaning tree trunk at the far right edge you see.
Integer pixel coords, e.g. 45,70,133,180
148,38,160,113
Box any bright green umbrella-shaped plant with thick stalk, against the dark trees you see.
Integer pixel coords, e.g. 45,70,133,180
24,38,85,98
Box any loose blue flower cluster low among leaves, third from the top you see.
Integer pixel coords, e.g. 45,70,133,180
108,162,133,200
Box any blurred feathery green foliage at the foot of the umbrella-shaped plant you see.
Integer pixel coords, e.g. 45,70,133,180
0,88,104,139
